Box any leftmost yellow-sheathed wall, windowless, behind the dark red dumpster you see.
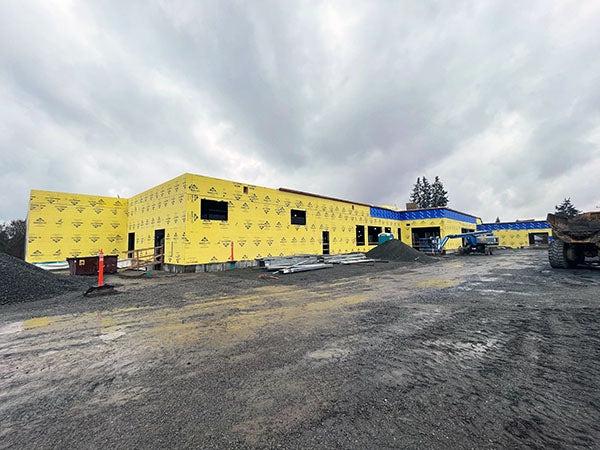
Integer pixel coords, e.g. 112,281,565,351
25,190,127,263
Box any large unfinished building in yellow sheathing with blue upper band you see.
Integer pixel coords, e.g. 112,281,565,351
26,173,481,270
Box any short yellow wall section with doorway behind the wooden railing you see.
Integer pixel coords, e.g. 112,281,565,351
127,174,188,264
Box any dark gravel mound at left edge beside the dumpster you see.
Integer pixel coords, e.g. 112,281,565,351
0,253,88,305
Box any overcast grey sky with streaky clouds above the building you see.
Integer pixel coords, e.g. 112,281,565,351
0,0,600,220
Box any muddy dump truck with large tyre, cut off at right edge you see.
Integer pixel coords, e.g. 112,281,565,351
547,211,600,269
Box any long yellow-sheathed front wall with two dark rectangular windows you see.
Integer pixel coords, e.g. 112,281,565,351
180,174,400,264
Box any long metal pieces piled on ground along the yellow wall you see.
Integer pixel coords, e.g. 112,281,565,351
259,253,378,274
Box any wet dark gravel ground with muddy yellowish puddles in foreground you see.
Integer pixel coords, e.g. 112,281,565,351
0,250,600,449
